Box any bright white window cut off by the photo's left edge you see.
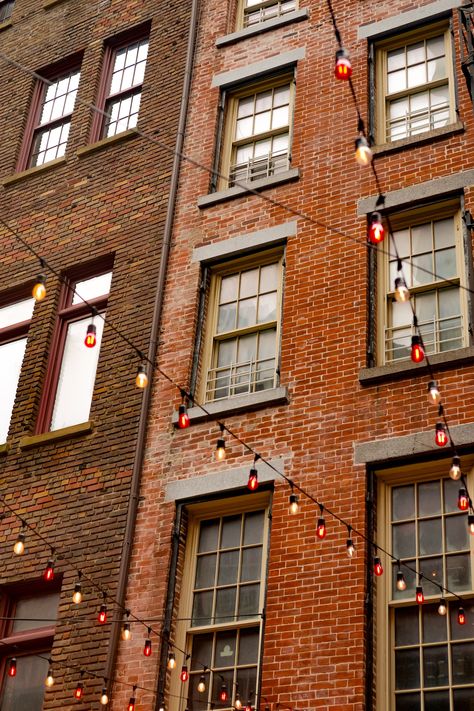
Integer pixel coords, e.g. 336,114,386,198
0,298,35,444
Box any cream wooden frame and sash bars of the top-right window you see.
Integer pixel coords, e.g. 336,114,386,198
374,19,457,145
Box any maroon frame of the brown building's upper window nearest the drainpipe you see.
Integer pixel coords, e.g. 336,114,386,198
89,23,151,143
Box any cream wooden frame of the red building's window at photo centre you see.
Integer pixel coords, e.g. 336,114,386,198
197,246,285,403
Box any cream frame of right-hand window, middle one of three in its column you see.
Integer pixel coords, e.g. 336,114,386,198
376,198,470,366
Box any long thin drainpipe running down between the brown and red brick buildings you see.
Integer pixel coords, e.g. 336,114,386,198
105,0,199,686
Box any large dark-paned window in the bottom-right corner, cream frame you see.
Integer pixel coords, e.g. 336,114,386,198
377,465,474,711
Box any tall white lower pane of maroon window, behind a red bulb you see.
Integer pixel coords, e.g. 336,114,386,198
51,317,104,430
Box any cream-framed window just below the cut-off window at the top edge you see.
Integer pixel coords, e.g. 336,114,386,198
221,75,294,187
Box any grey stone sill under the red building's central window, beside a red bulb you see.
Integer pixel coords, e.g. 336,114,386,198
172,387,289,425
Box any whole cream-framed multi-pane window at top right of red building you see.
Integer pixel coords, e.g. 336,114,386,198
376,24,455,143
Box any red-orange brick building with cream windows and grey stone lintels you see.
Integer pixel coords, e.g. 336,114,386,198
113,0,474,711
